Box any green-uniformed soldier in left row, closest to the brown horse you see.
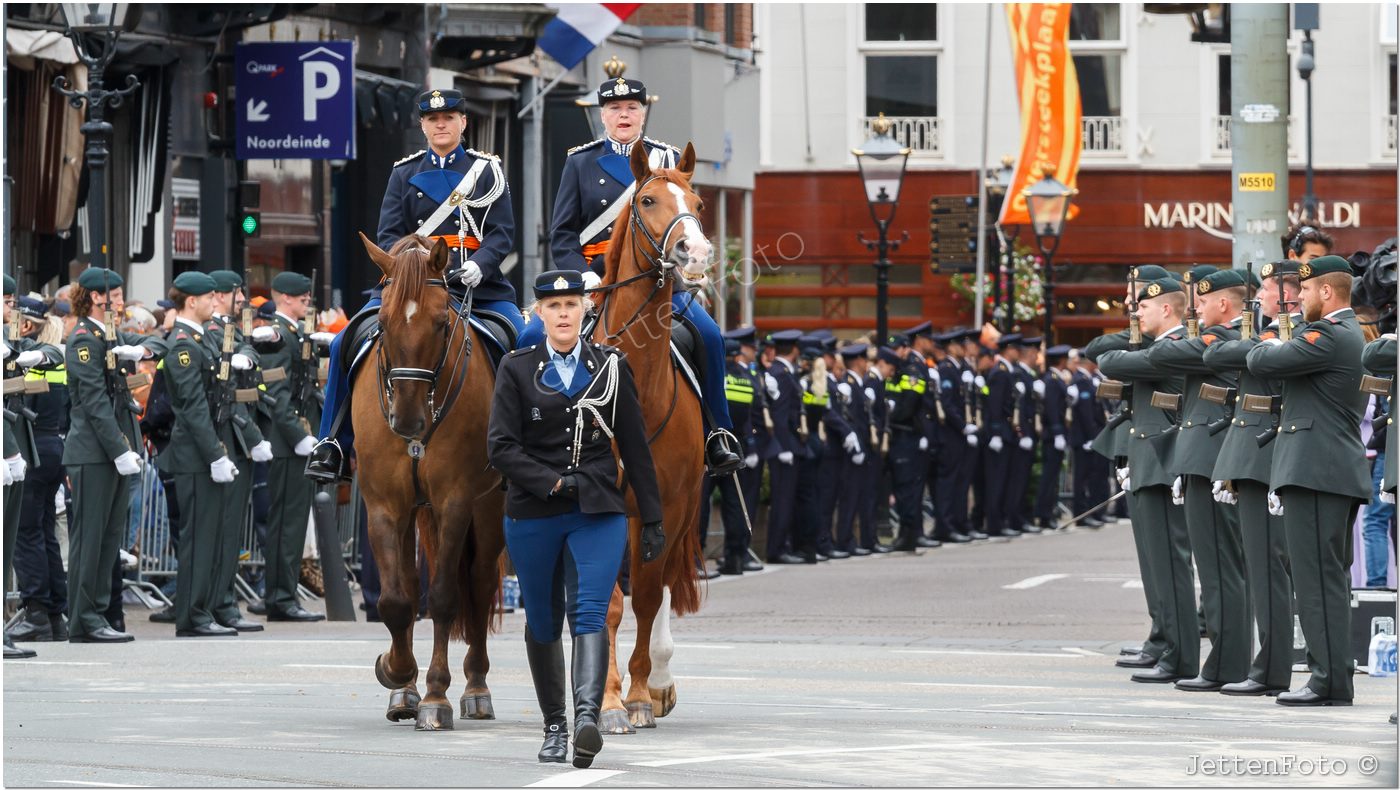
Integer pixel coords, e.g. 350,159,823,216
258,272,325,622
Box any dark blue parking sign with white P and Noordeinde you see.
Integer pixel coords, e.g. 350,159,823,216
234,41,356,160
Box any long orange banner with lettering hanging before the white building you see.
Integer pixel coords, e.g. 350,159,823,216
998,3,1084,226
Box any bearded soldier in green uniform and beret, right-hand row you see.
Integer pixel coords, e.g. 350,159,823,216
1246,255,1371,706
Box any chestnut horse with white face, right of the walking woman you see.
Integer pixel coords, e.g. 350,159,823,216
594,138,711,734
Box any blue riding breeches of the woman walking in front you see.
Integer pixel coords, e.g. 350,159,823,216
505,506,627,644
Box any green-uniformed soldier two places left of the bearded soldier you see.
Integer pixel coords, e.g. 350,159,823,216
1147,268,1250,692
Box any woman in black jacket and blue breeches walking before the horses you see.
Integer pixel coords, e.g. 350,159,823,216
487,269,665,768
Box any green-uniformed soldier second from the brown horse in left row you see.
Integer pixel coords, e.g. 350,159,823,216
204,269,276,632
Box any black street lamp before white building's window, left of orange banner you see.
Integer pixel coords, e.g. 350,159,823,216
851,112,910,343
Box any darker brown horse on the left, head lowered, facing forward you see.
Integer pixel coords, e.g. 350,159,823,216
351,234,505,730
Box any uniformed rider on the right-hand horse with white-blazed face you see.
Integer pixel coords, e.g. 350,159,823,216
517,77,743,475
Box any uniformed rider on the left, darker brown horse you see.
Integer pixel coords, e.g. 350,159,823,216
307,90,525,482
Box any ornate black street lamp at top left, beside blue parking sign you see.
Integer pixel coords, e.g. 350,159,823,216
53,3,140,269
